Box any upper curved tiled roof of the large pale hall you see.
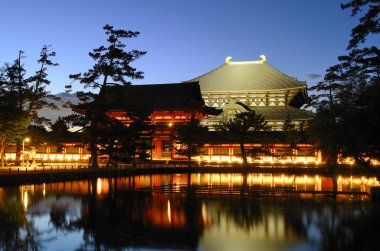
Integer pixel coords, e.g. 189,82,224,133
189,61,306,92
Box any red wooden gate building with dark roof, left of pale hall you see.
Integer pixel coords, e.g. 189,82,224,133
74,82,221,159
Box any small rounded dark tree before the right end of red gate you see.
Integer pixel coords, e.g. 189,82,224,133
171,114,208,166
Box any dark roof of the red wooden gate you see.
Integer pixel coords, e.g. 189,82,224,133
74,82,220,114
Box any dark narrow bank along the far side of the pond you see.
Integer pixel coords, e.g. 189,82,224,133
0,165,375,187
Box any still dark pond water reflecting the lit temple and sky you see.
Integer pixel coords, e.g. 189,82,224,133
0,174,380,251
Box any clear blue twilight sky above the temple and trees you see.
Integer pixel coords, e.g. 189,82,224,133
0,0,362,93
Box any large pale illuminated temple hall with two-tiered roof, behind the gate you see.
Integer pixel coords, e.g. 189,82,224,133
189,55,313,131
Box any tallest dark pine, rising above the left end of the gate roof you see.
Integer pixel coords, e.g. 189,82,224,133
66,25,146,168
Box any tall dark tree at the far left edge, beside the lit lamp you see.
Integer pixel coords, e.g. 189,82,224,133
0,46,58,164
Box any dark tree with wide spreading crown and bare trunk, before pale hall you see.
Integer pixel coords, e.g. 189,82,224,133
217,110,269,166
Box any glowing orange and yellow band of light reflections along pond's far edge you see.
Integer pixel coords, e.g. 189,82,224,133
14,173,378,209
